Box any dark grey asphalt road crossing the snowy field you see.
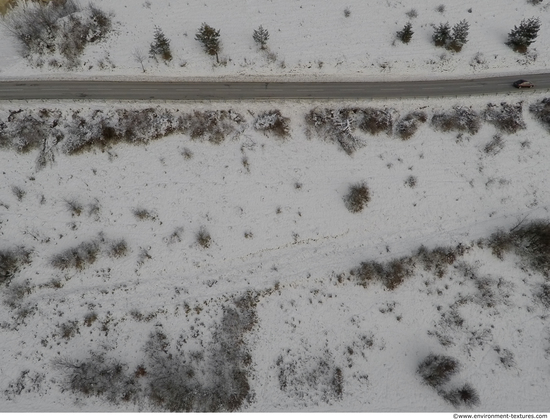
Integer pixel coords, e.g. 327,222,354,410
0,73,550,100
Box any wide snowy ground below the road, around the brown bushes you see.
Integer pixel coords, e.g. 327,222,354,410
0,92,550,412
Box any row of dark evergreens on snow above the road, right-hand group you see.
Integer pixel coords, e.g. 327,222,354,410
396,18,540,53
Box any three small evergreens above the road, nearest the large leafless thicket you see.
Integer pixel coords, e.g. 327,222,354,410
149,23,269,65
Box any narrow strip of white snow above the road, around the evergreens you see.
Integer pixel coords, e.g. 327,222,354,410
0,0,550,80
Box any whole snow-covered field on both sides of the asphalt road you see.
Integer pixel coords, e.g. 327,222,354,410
0,0,550,412
